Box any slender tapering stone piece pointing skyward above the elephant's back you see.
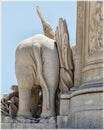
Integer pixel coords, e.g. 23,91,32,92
36,6,55,39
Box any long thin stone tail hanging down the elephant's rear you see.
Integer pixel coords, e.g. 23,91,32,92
33,43,50,109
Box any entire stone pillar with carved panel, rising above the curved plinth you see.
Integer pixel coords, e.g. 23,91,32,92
74,1,103,87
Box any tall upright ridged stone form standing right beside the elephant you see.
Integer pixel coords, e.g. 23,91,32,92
55,18,74,92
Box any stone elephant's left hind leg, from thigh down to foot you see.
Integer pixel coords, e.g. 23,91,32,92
15,50,34,116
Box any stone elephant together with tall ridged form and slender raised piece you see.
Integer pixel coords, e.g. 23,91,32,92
15,15,74,117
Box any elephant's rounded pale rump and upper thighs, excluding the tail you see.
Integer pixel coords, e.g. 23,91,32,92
15,35,59,87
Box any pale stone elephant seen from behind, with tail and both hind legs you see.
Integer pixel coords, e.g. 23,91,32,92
15,34,59,117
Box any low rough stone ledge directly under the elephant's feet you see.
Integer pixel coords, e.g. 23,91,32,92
1,116,56,129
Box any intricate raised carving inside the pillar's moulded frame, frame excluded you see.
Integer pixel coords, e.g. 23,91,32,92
88,2,103,56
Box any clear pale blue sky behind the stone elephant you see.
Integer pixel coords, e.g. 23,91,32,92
1,1,77,96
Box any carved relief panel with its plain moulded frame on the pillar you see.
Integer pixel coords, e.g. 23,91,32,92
84,1,103,65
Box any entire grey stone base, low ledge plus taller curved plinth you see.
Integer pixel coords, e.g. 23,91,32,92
1,84,103,129
